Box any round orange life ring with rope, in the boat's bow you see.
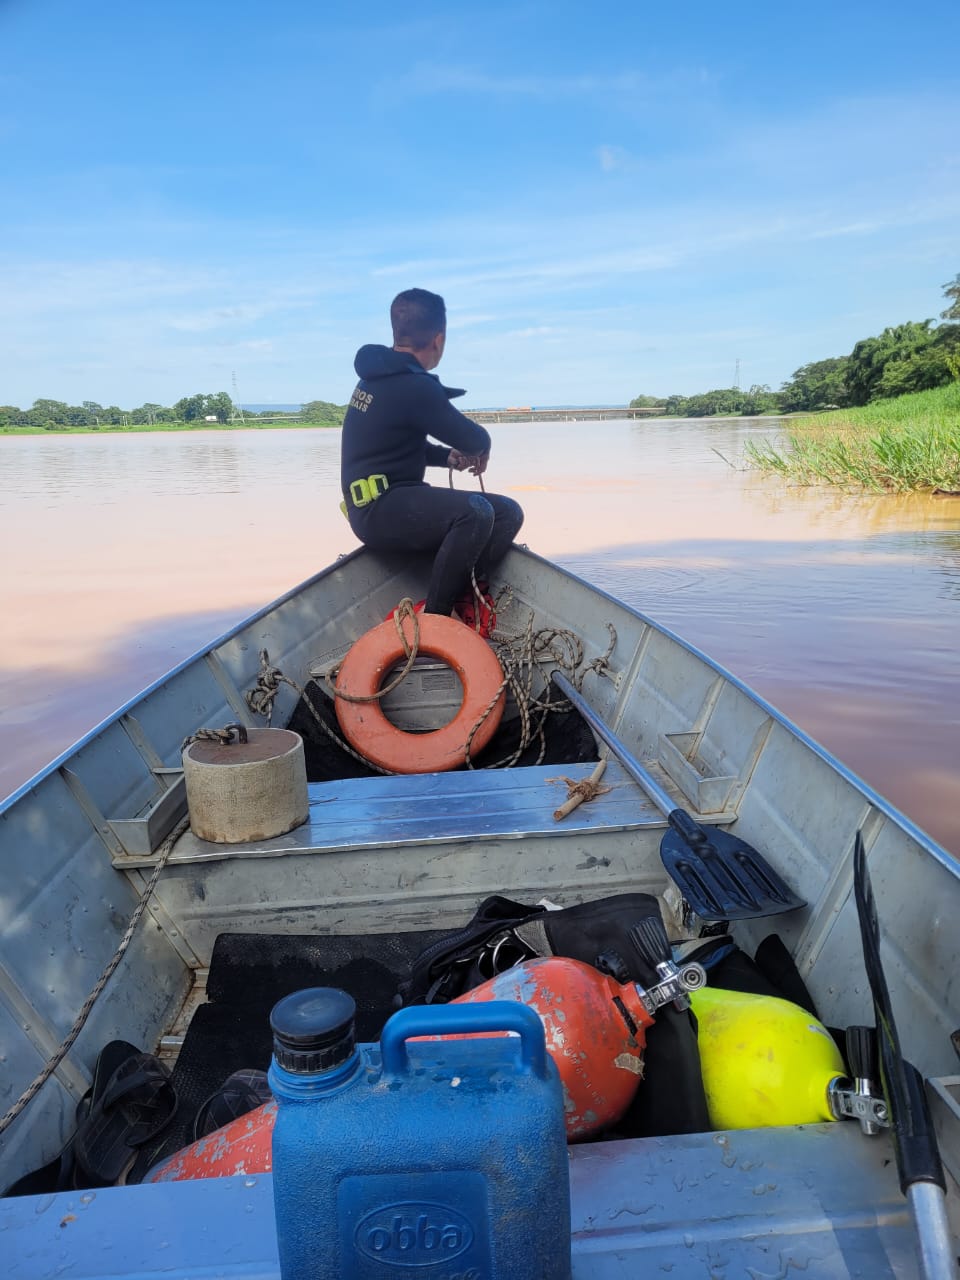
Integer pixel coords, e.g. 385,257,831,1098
337,613,506,773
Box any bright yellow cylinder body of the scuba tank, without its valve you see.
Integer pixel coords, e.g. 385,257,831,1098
690,987,846,1129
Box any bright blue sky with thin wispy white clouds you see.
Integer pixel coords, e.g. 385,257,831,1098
0,0,960,407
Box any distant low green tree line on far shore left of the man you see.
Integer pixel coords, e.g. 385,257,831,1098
0,392,346,431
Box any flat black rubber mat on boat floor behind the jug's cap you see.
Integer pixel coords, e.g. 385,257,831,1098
127,929,444,1183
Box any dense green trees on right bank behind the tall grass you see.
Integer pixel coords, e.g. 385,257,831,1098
630,273,960,417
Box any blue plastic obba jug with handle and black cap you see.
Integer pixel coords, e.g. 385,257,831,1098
270,987,571,1280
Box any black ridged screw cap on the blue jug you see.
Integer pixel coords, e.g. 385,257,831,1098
270,987,357,1075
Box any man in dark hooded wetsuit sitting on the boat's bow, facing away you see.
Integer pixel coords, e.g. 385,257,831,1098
340,289,524,629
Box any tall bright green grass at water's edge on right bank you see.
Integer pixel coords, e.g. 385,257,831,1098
745,383,960,493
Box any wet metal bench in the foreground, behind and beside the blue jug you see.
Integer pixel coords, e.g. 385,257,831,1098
7,1124,916,1280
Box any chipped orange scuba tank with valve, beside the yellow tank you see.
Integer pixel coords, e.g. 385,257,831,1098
453,919,707,1142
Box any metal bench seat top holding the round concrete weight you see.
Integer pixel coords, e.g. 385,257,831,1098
163,759,706,861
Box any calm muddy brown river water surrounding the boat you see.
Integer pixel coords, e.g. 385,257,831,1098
0,419,960,854
